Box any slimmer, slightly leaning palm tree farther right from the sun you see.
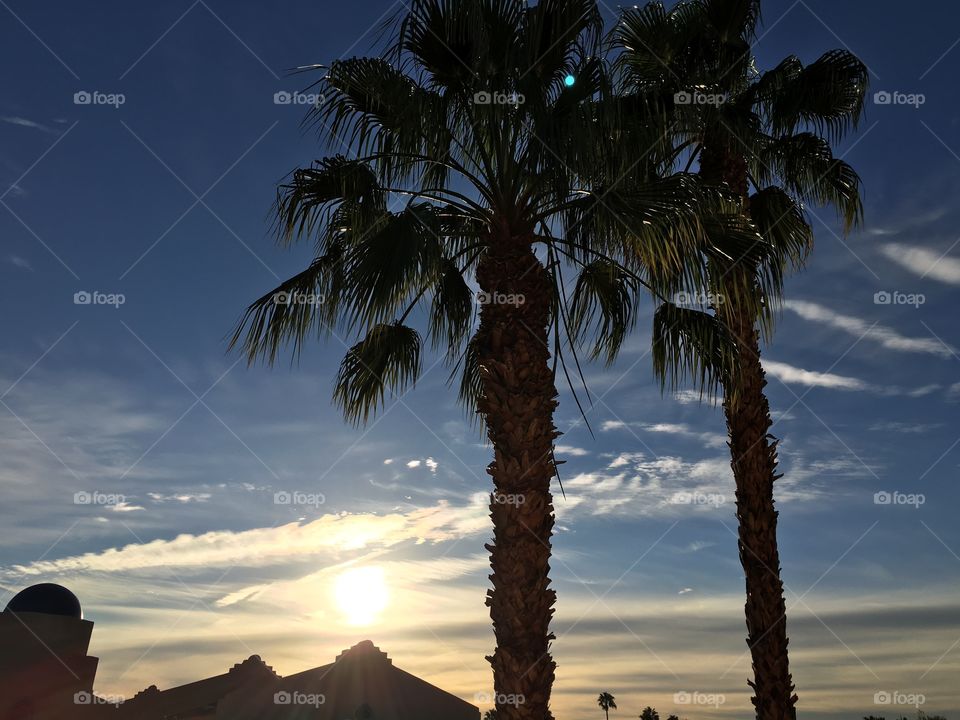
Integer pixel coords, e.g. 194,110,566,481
614,0,868,720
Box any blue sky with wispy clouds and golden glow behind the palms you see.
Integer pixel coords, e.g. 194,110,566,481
0,0,960,720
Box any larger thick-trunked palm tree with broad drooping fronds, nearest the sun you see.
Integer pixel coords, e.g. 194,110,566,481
233,0,720,720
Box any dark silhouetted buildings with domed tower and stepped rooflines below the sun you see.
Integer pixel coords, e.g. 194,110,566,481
0,583,480,720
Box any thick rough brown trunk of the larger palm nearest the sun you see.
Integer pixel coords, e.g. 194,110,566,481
476,226,559,720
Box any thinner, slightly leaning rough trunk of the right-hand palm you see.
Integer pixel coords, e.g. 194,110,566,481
700,137,797,720
